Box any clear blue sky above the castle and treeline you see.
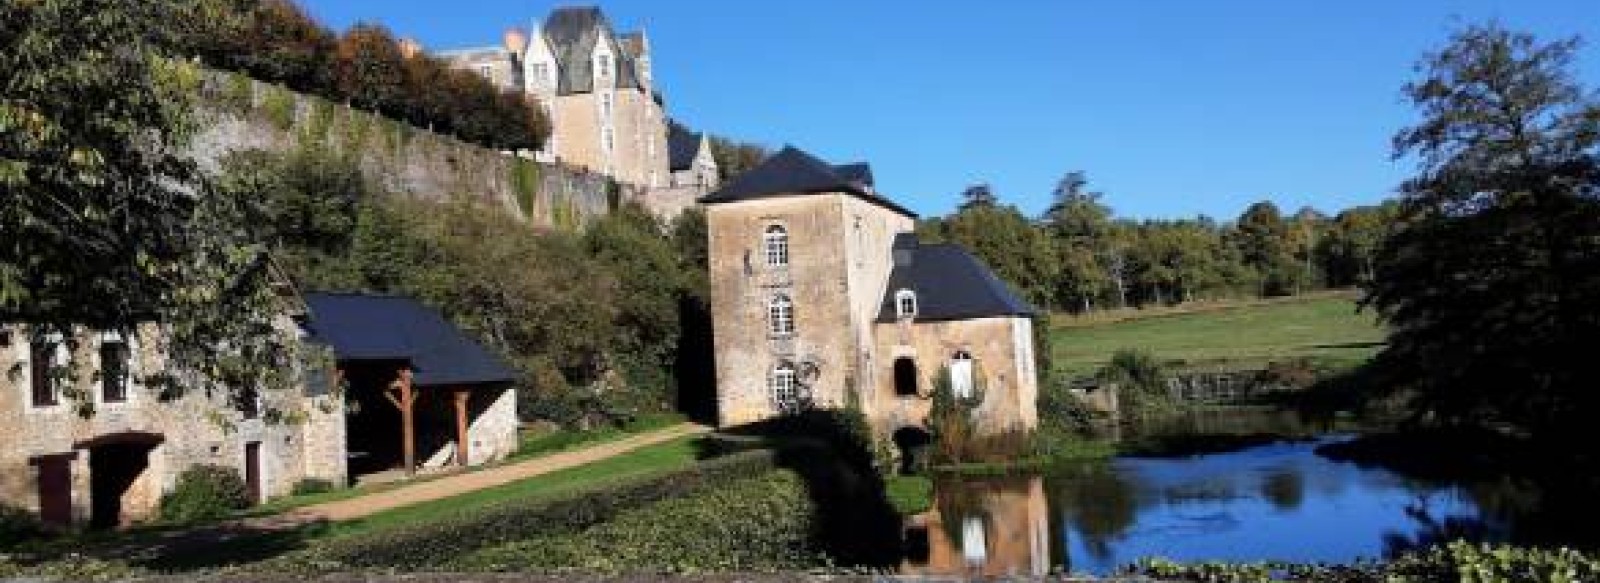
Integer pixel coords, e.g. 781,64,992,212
302,0,1600,218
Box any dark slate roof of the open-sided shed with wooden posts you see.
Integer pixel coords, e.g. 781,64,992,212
306,293,517,386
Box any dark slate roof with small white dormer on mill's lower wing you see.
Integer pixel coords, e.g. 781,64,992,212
878,234,1035,322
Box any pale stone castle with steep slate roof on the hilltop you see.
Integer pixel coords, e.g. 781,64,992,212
437,6,693,191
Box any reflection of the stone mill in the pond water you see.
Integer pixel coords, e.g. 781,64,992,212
901,477,1050,577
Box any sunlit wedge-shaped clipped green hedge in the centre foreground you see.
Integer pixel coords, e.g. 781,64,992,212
453,471,827,573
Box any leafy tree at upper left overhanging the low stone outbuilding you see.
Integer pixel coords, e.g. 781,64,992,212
0,0,294,407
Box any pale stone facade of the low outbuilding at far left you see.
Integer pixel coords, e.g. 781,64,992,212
0,317,346,527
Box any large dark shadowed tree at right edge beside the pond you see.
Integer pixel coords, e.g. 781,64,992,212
1365,24,1600,442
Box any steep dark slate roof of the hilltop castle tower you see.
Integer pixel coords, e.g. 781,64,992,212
544,6,640,94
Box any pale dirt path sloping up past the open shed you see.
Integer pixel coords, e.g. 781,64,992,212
265,423,710,529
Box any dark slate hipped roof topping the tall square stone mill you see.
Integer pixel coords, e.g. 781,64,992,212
699,146,917,218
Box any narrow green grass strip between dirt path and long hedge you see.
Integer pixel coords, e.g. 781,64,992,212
325,436,699,535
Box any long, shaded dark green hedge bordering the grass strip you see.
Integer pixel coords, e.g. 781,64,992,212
286,450,776,570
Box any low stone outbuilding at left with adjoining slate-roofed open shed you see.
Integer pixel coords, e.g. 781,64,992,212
0,295,517,529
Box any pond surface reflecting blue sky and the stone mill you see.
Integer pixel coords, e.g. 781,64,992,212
904,437,1526,577
